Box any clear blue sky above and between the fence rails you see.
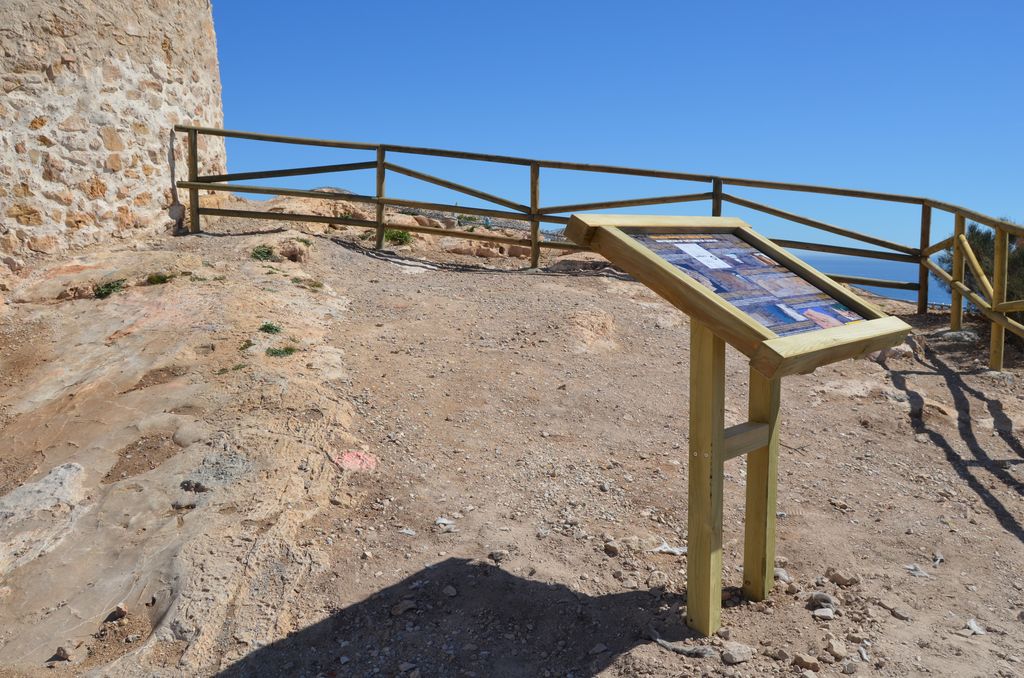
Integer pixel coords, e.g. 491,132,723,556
214,0,1024,262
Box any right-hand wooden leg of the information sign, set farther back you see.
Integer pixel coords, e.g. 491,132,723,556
743,369,781,600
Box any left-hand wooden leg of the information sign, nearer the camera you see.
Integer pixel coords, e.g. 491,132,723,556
686,317,725,635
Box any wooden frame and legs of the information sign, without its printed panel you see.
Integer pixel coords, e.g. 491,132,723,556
565,214,910,635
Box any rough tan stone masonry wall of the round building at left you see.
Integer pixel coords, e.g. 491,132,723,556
0,0,225,270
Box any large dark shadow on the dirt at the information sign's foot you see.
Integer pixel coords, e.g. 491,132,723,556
220,558,694,678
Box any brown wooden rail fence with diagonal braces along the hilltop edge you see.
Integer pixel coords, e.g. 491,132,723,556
174,125,1024,370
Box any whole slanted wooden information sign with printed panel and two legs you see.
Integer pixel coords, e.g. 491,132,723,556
565,214,910,635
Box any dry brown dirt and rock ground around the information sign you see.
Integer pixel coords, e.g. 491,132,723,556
0,208,1024,678
